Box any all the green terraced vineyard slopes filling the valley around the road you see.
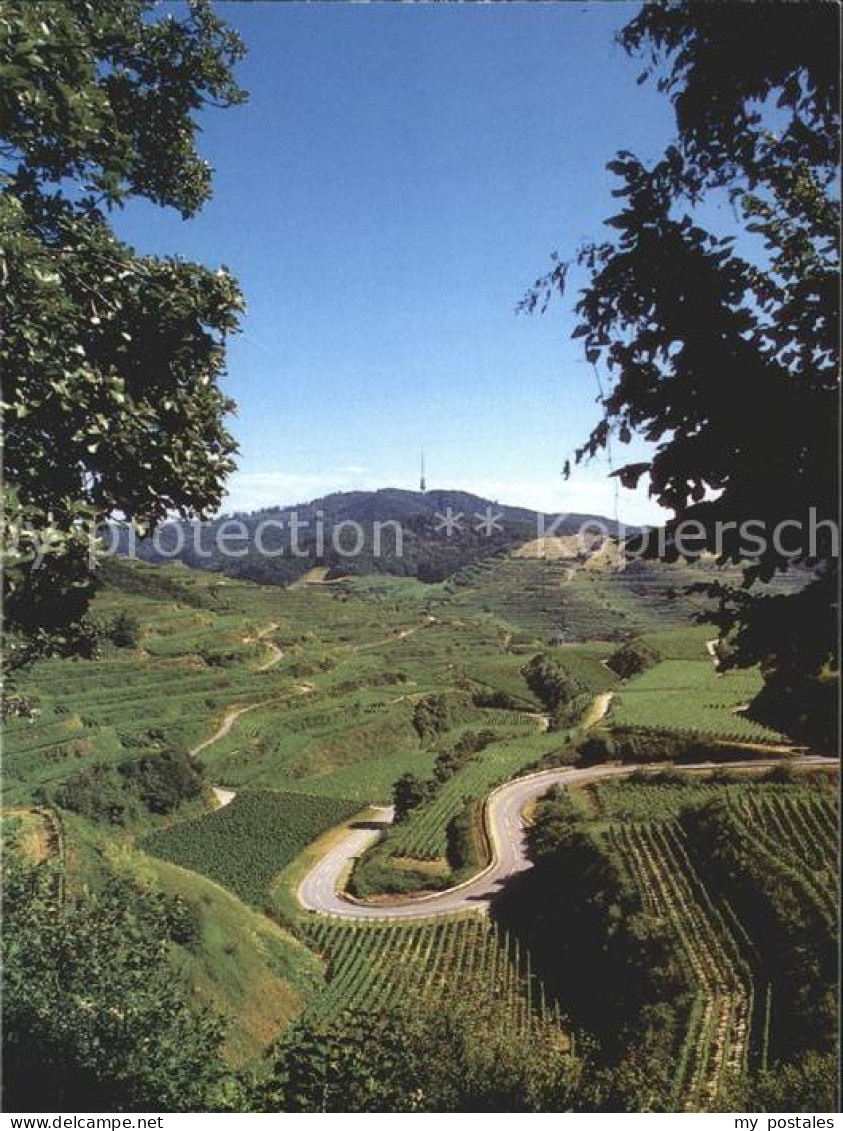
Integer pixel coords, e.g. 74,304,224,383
3,549,836,1111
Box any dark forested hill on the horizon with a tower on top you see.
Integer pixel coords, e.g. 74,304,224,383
110,487,618,585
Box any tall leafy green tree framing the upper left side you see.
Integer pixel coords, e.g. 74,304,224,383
0,0,244,659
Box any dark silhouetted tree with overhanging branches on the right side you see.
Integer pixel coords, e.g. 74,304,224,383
523,0,840,741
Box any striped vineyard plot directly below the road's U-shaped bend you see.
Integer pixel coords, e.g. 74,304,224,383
304,915,567,1042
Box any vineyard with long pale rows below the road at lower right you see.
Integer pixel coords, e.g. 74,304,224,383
568,775,838,1111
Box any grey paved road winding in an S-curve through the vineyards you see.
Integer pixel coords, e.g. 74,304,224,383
298,756,834,920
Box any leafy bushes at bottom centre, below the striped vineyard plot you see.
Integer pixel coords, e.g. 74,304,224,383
260,984,582,1112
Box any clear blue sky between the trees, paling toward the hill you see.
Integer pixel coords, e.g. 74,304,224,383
117,2,671,521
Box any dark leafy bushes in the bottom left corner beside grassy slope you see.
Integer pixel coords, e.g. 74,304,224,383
3,854,225,1112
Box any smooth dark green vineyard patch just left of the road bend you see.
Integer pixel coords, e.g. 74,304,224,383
143,791,360,907
